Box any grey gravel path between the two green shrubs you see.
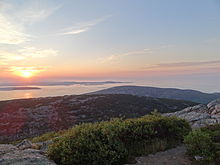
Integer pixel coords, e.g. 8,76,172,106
126,146,191,165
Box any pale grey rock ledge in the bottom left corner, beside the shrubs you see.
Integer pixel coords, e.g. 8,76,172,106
0,140,56,165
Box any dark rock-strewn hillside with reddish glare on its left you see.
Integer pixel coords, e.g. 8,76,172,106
0,95,196,142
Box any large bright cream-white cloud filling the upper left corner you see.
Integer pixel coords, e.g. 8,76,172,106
0,1,59,45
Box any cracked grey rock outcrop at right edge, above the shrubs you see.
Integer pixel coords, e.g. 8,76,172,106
164,99,220,128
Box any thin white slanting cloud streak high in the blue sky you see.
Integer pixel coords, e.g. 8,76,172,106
59,15,112,35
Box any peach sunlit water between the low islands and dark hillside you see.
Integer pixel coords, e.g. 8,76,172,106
0,83,131,101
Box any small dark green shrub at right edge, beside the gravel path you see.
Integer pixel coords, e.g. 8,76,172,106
184,124,220,162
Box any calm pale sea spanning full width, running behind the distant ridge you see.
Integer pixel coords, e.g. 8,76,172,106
0,79,214,101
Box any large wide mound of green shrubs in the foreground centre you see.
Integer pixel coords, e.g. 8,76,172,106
48,115,191,165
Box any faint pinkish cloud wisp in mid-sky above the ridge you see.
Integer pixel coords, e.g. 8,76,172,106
99,49,153,62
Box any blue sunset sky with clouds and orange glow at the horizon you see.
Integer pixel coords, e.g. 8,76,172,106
0,0,220,92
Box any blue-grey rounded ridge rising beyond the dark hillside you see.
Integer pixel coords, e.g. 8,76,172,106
90,86,220,104
